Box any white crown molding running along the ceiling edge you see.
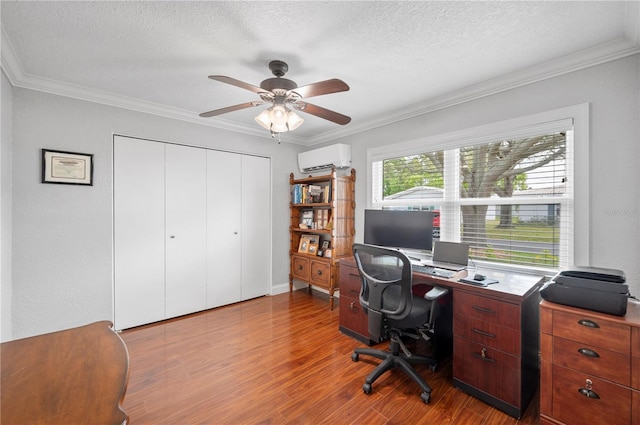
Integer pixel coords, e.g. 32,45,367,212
0,24,640,146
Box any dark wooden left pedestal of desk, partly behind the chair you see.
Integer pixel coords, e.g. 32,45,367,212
338,257,373,345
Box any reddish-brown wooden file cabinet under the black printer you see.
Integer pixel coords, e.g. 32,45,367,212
540,301,640,425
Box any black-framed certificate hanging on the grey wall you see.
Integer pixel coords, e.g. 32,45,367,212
42,149,93,186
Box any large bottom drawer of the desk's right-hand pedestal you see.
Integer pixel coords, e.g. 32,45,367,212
453,335,521,406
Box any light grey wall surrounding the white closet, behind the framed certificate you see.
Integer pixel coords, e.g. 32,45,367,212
9,88,300,338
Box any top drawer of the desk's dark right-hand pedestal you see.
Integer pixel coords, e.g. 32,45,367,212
453,290,520,330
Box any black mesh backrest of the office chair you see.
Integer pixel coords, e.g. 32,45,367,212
353,243,412,341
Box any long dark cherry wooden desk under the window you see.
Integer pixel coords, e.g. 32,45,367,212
339,257,545,418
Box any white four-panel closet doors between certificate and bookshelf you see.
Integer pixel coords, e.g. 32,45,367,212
114,136,271,329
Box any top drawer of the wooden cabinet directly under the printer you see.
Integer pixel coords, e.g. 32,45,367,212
553,311,631,355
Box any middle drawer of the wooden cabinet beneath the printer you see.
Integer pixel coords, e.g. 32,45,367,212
553,337,631,386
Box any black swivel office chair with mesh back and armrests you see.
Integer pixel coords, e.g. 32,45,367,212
351,244,447,403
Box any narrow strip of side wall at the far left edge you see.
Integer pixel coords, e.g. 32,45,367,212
0,72,13,341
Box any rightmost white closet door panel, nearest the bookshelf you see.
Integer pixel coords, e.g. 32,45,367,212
241,155,271,300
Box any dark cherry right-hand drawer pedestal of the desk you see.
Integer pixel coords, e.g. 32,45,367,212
453,285,539,418
